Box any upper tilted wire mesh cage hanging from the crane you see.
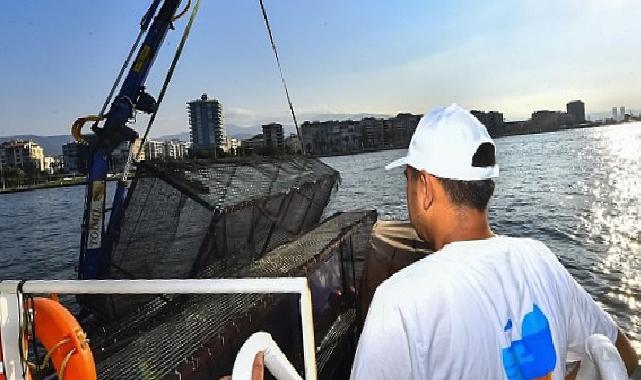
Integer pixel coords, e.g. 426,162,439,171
79,156,339,321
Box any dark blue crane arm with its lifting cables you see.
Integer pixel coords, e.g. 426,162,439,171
72,0,305,280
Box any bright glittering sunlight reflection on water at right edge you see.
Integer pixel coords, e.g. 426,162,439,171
577,124,641,348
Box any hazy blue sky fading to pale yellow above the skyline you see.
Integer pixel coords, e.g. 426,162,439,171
0,0,641,135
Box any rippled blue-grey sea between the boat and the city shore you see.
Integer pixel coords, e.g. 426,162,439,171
0,123,641,349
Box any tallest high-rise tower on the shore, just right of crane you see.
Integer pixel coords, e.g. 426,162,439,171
187,94,226,151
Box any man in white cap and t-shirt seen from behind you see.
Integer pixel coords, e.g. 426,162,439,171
352,105,637,380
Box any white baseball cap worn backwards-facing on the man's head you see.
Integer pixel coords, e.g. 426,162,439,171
385,104,499,181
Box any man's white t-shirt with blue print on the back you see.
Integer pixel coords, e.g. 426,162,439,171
352,236,618,380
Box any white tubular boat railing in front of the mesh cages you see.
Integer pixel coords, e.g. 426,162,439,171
0,277,317,380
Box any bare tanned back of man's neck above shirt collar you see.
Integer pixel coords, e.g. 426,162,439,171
434,208,494,251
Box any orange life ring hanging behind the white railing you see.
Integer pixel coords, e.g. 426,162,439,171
28,297,97,380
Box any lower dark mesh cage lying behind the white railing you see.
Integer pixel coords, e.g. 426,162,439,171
92,211,376,379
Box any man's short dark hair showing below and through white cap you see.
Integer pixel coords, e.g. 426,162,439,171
410,143,496,211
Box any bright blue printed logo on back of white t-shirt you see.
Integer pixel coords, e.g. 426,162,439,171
501,305,556,380
